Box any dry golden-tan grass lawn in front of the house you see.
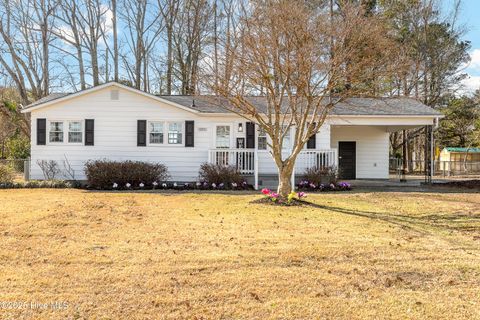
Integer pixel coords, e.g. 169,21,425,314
0,189,480,319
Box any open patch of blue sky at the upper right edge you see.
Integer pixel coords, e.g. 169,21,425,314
443,0,480,93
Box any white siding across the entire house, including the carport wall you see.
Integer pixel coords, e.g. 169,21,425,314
30,87,432,182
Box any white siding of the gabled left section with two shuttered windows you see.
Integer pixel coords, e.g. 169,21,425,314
31,88,239,182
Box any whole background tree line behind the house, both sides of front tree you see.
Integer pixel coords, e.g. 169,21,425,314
0,0,466,105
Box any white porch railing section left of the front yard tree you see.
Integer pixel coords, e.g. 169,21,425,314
208,149,256,174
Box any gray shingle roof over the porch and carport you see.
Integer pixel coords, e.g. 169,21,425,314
160,96,442,116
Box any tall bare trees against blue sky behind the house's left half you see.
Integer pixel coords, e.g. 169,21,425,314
0,0,246,104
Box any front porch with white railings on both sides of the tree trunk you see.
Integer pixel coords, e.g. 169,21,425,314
208,148,338,189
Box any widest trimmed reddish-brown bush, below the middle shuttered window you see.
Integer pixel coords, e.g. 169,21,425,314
85,160,169,190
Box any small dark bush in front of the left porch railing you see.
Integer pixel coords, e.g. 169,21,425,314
198,163,246,189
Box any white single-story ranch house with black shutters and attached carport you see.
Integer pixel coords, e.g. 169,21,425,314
23,82,441,188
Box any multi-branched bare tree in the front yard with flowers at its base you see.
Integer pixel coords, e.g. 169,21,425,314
209,0,395,197
